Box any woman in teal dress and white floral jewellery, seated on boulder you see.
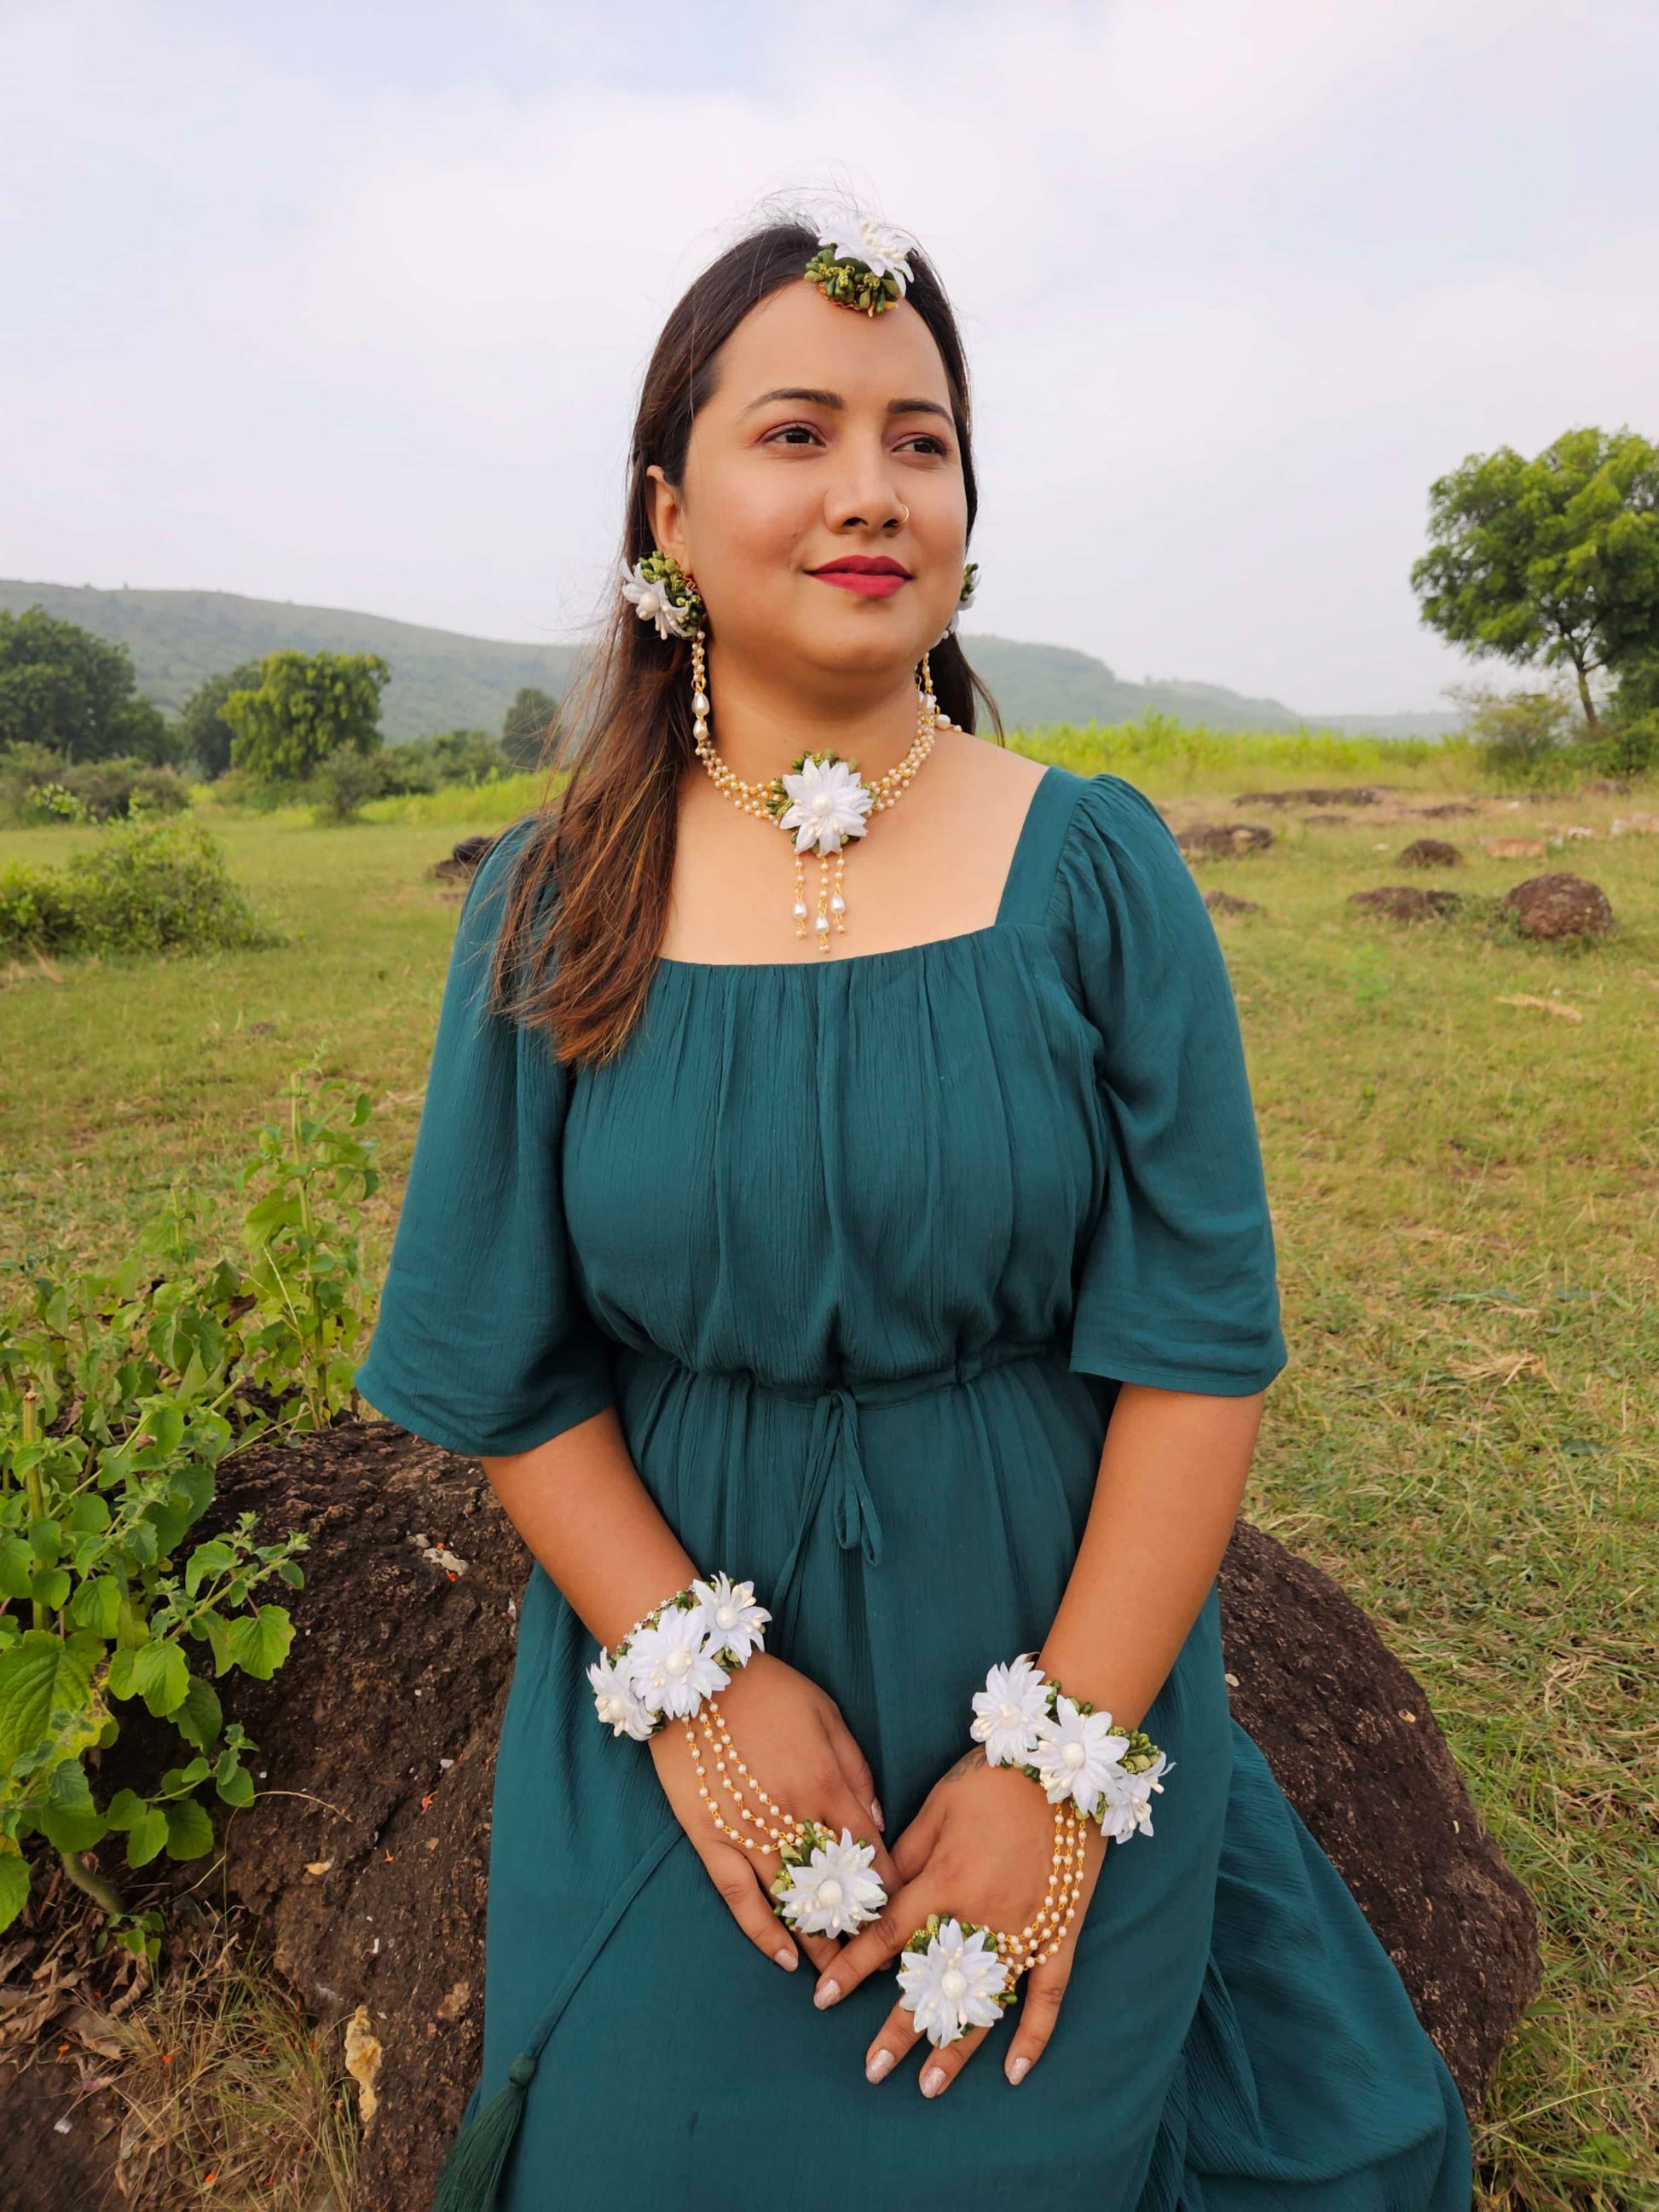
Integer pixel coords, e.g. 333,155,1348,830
361,211,1471,2212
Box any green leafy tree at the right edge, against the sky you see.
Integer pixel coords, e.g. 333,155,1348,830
1411,429,1659,735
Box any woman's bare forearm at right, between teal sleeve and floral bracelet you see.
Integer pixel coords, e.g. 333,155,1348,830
1042,1383,1263,1728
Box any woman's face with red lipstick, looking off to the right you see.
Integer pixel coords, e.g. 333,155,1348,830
650,281,967,677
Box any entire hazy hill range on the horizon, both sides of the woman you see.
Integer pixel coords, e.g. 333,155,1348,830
0,580,1455,743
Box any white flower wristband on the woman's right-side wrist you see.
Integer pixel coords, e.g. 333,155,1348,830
968,1652,1172,1843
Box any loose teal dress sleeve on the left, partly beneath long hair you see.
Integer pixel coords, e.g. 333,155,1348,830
356,829,613,1456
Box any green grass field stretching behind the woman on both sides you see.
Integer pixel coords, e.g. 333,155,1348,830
0,732,1659,2212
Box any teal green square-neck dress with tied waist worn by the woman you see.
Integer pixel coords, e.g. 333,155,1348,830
358,767,1471,2212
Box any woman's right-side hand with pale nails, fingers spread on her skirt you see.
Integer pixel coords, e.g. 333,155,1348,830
814,1750,1106,2097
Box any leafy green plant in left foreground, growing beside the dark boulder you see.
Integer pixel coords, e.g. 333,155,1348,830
0,1079,376,1955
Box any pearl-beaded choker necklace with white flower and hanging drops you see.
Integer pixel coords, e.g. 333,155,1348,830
692,637,951,953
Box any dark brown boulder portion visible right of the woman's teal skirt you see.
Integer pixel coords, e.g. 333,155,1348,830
1221,1524,1541,2115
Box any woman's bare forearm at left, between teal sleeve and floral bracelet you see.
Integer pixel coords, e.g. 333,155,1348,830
480,1406,694,1643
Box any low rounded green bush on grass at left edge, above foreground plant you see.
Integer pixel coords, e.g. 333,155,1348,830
0,821,272,958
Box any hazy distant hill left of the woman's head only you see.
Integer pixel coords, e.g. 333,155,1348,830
0,580,577,743
